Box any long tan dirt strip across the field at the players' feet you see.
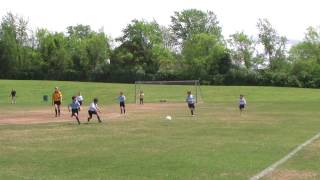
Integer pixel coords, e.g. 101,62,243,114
0,103,185,124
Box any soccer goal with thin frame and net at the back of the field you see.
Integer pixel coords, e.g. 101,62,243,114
134,80,203,103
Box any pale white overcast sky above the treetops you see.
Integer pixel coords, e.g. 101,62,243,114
0,0,320,41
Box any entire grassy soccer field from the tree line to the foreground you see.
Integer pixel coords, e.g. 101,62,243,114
0,80,320,180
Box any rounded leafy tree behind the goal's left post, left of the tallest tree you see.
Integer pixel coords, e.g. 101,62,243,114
114,20,170,76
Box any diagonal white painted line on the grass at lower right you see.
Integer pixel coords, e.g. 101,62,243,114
250,132,320,180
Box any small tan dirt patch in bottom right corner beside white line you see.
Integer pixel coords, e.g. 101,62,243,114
266,170,319,180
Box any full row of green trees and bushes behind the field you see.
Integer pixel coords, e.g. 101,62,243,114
0,9,320,87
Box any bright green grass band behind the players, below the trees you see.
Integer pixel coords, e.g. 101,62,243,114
0,80,320,107
